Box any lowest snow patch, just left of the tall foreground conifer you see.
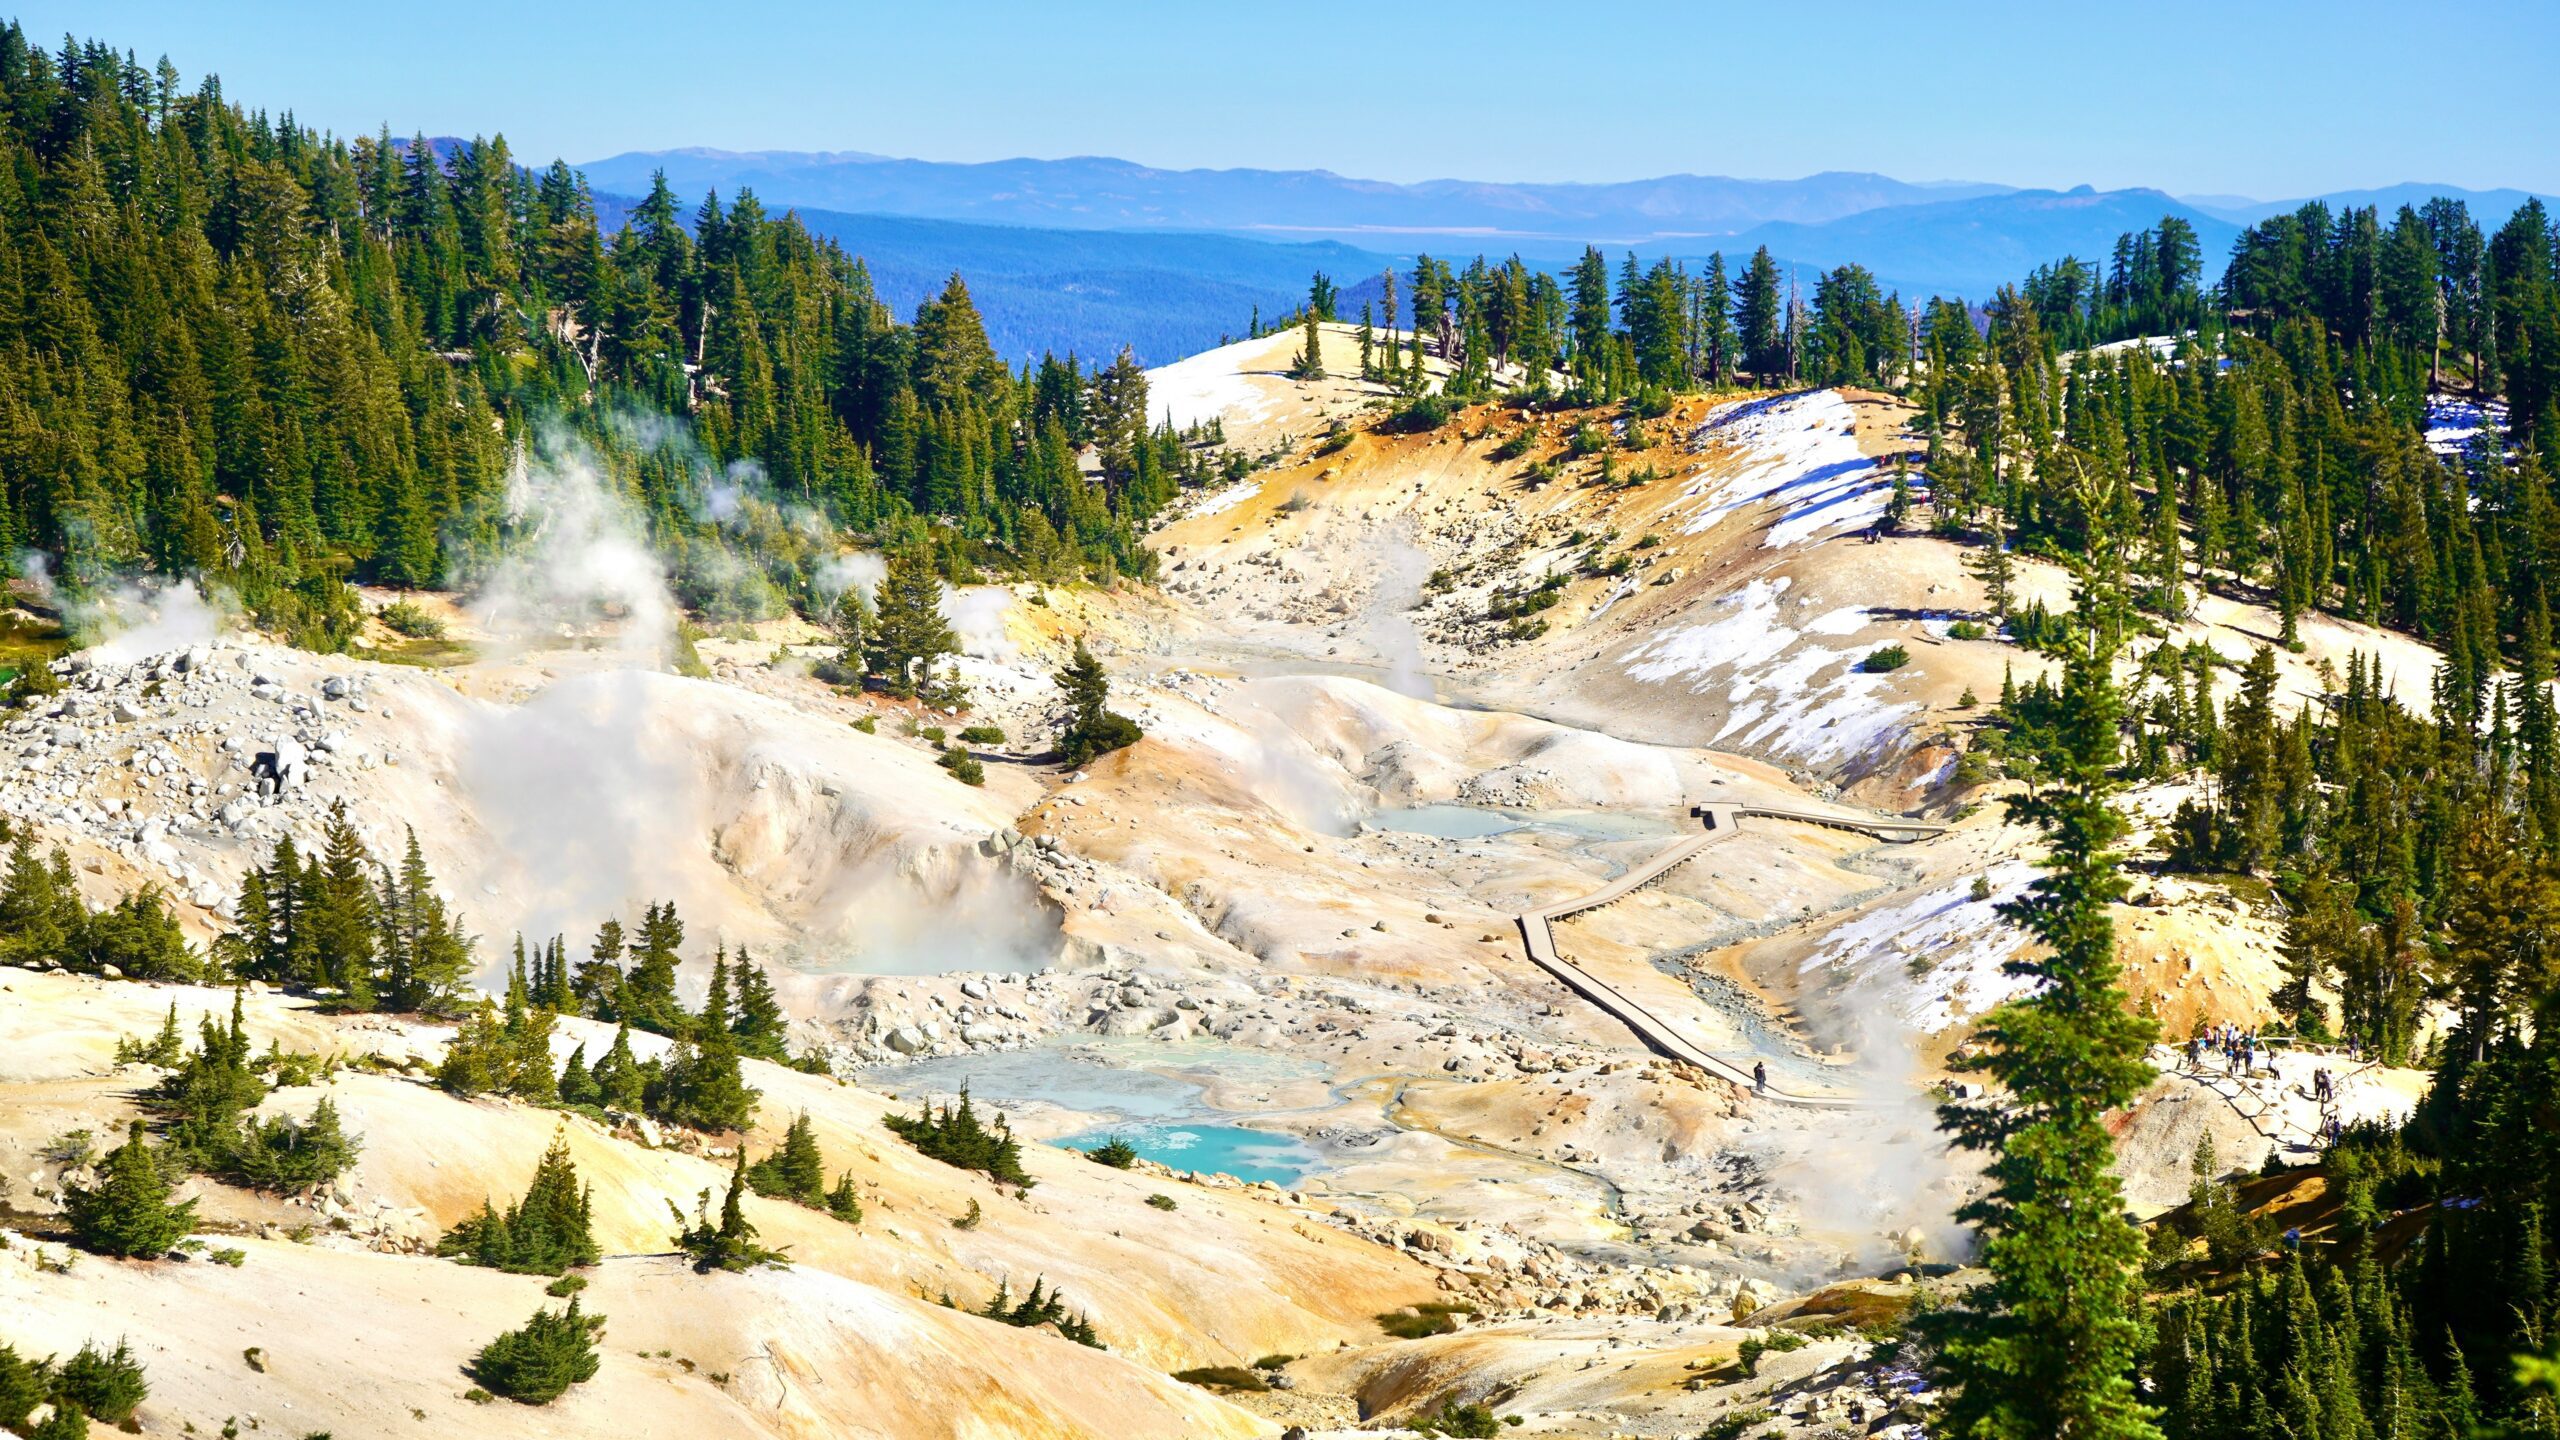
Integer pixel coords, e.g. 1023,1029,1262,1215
1800,861,2035,1035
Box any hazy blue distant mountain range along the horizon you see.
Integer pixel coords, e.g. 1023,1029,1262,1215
581,149,2550,364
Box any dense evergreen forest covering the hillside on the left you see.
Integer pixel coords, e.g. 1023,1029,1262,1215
0,26,1228,646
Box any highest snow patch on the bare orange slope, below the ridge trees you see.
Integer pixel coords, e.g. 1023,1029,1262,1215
1679,389,1892,548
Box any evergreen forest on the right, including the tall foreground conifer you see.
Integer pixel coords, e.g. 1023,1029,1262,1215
1274,181,2560,1440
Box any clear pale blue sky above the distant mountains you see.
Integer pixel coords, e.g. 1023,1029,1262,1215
24,0,2560,200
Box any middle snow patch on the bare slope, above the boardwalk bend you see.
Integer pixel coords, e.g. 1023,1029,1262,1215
1623,577,1920,764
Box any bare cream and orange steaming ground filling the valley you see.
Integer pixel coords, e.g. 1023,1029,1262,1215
0,333,2424,1435
